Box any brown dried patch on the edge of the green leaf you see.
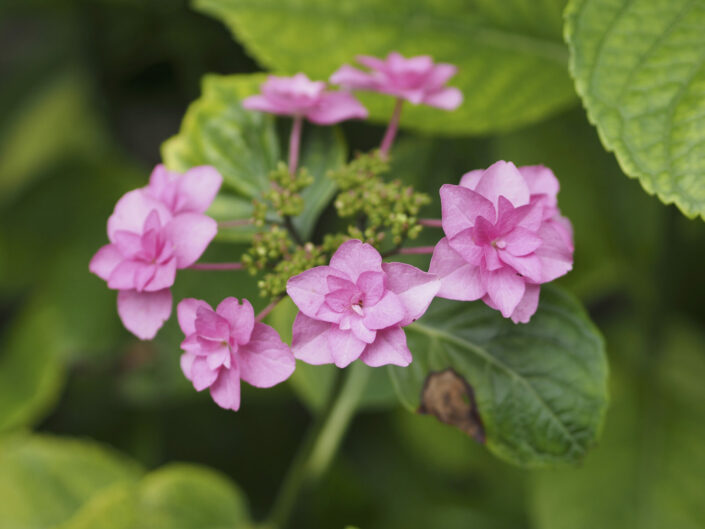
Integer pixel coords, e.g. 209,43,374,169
418,368,485,443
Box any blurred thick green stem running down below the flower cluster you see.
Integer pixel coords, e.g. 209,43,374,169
265,363,369,529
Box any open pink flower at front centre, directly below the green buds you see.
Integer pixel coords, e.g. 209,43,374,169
286,240,439,367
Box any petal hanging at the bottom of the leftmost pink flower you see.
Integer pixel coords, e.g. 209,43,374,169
118,288,171,340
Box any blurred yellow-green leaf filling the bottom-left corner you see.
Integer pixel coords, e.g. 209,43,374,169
0,435,140,529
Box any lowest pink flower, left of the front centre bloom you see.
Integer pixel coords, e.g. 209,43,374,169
177,298,296,411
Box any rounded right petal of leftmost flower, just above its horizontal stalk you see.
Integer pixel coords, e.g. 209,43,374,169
164,213,218,268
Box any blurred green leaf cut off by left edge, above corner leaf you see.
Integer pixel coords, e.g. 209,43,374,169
0,298,64,434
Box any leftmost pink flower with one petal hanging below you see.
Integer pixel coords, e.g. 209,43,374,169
89,166,220,340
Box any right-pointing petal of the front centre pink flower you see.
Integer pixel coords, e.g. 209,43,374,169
382,263,441,327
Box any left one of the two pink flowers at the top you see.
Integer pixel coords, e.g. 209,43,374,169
242,73,367,125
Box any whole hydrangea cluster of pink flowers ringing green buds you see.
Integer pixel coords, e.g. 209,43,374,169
89,53,573,410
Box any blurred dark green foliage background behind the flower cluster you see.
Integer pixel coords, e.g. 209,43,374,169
0,0,705,529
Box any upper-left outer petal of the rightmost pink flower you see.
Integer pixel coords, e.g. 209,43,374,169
440,184,497,237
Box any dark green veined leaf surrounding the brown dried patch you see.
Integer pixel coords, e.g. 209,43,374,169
389,286,607,466
